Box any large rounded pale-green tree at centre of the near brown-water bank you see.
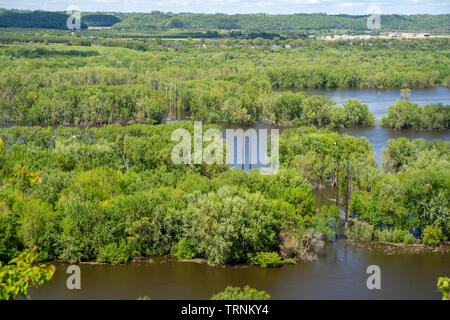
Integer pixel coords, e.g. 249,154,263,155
183,186,281,264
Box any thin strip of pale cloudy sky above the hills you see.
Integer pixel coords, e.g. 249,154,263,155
0,0,450,14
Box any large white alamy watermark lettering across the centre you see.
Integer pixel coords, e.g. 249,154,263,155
171,121,280,175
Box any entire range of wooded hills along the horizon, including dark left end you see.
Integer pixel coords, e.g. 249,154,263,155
0,10,450,33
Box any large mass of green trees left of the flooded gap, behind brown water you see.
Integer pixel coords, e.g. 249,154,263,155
0,122,348,264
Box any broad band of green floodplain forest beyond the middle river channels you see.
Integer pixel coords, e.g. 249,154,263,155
0,36,449,128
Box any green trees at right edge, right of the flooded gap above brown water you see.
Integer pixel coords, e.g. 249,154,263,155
350,138,450,240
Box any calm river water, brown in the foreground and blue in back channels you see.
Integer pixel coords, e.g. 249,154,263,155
24,88,450,299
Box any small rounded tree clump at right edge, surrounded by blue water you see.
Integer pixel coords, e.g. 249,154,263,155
381,101,450,129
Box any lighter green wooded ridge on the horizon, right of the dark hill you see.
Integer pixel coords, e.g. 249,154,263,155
115,12,449,32
